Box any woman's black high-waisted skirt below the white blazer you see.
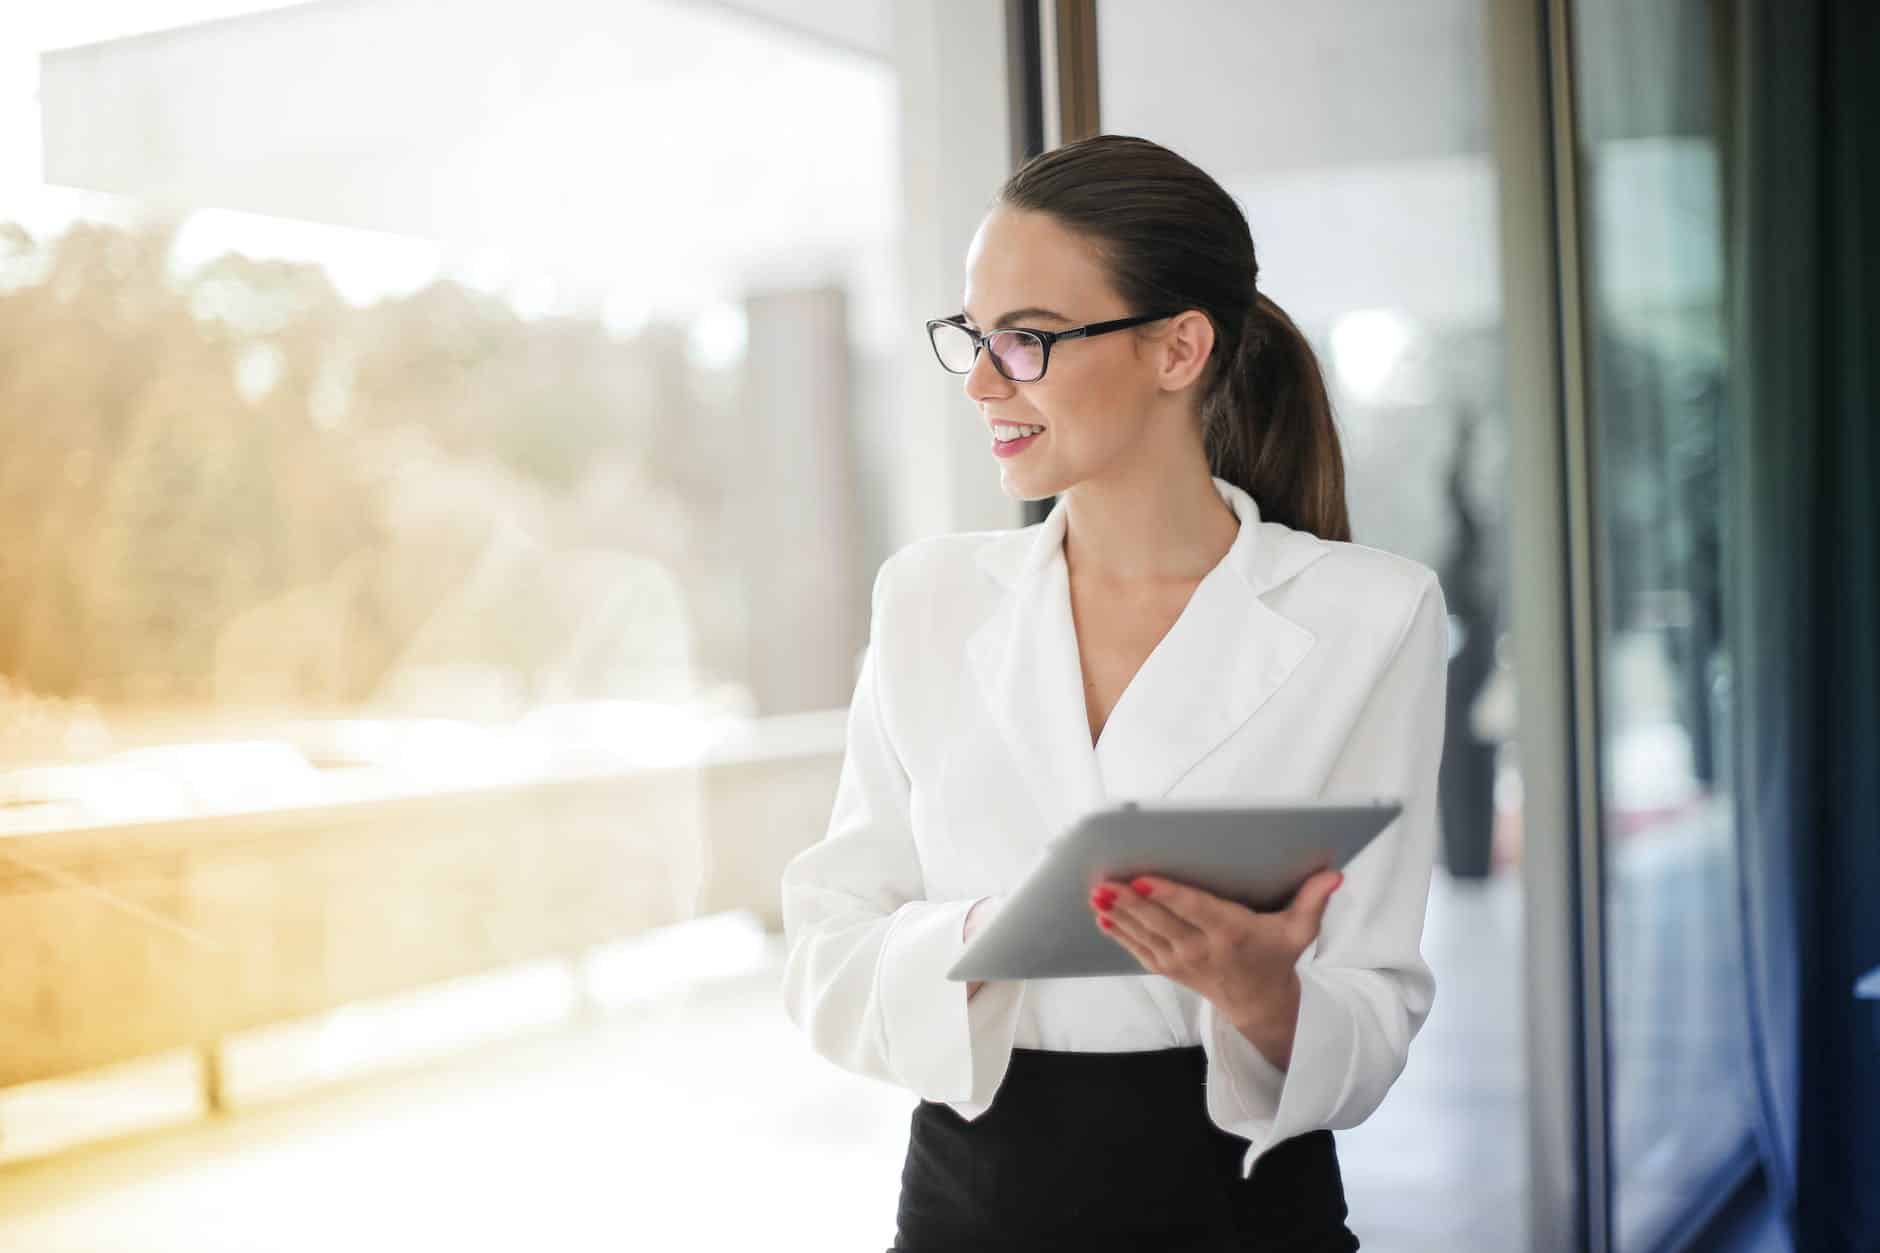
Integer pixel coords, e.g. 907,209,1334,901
893,1044,1357,1253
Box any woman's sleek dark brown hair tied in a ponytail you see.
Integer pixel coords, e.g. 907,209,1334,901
993,135,1352,540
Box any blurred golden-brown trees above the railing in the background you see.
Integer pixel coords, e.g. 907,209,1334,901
0,222,729,718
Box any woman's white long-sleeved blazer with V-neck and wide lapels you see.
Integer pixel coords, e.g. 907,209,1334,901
782,478,1449,1176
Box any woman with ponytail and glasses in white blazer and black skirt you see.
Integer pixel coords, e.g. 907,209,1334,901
782,135,1448,1253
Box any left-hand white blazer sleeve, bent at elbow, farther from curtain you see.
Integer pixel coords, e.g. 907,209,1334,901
782,559,1023,1104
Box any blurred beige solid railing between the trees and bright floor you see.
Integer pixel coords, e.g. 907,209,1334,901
0,711,844,1104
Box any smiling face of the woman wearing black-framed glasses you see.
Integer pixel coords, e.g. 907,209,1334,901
963,207,1214,500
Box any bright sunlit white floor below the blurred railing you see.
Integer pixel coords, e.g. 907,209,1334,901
0,978,910,1253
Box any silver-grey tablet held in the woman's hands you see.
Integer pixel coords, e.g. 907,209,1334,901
948,800,1402,980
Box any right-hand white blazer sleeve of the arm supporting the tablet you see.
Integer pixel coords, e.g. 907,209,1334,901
1199,574,1449,1176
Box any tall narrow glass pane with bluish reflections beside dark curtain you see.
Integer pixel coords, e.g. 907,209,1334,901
1575,0,1752,1249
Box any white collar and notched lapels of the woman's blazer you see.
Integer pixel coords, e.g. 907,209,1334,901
966,476,1327,837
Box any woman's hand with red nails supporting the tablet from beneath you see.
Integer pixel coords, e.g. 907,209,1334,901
1090,869,1344,1030
